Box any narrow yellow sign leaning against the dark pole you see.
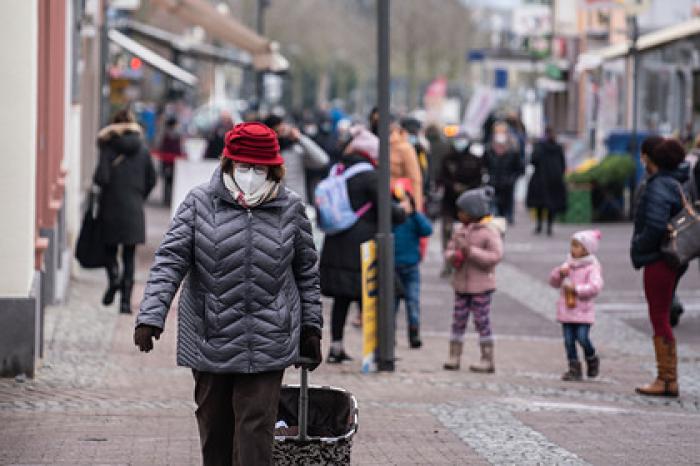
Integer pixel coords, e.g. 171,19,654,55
360,240,379,374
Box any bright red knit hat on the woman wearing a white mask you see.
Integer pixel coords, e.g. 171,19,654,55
224,122,284,165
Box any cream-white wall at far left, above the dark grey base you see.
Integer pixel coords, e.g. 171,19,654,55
0,0,38,297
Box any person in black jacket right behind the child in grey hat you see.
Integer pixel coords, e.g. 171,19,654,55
438,134,486,276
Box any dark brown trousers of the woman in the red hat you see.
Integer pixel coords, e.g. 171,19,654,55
192,371,284,466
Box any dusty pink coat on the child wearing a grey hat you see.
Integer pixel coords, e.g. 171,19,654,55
445,220,503,294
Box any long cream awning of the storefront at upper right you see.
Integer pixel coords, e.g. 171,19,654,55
576,18,700,73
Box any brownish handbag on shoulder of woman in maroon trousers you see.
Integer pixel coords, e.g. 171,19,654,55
661,186,700,268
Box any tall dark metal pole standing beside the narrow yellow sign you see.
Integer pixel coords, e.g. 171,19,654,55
377,0,395,372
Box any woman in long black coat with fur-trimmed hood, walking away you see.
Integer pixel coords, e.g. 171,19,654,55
94,110,156,314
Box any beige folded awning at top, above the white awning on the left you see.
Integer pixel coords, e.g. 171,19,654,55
153,0,289,72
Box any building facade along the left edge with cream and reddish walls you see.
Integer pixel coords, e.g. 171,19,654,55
0,0,102,376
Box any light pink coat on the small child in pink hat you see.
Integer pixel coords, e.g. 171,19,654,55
549,254,603,324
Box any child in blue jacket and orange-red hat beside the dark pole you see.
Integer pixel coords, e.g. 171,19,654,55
394,178,433,348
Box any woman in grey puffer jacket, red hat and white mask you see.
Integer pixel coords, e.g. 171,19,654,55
134,123,322,465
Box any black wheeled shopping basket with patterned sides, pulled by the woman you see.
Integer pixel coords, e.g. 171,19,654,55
272,369,358,466
